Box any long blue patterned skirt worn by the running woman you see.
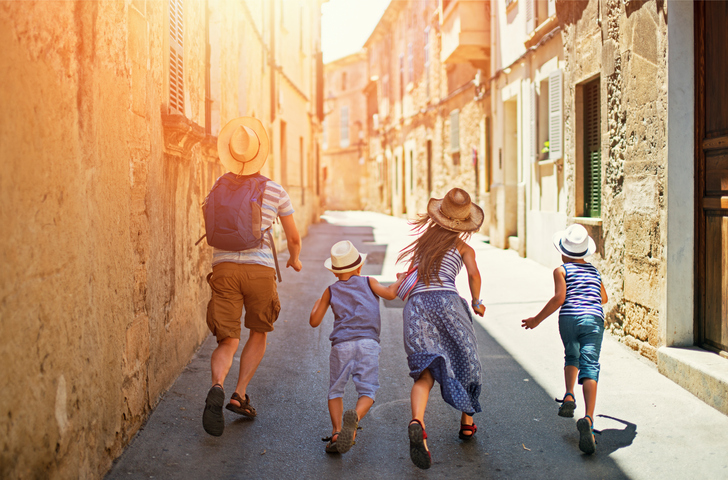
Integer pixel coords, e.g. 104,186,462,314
404,290,482,415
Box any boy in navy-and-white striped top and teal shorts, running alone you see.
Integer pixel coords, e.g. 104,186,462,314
521,224,607,454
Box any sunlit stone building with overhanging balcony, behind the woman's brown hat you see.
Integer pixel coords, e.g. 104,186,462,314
364,0,490,222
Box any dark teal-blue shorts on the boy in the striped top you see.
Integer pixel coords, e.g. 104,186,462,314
559,315,604,384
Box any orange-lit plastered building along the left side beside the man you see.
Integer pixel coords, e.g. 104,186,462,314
0,0,323,478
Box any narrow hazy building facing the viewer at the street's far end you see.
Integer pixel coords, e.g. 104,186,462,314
321,52,368,210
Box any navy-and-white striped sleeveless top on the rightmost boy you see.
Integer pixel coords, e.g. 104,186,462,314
559,263,604,319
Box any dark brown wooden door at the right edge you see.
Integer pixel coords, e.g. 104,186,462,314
695,1,728,352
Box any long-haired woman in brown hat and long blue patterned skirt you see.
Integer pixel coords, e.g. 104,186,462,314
398,188,485,469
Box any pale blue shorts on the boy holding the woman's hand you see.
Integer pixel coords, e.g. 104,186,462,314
329,338,382,400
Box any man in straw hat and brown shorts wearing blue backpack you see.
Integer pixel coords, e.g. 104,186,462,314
202,117,301,436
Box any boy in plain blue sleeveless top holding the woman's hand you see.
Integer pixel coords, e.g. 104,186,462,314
309,240,404,453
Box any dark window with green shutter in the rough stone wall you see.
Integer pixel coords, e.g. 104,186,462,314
583,78,602,217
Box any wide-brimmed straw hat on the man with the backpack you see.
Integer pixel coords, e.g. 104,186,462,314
217,117,270,175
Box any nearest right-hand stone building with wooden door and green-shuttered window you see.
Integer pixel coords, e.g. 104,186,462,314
556,0,728,413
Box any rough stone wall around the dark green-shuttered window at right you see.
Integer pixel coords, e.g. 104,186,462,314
557,0,667,360
